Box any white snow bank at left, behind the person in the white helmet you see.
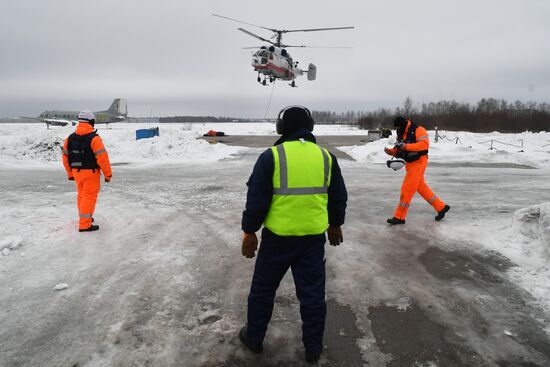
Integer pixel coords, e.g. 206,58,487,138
0,124,245,164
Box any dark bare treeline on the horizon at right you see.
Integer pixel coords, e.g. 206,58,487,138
357,97,550,133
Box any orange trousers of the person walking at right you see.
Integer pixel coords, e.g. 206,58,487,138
394,156,445,219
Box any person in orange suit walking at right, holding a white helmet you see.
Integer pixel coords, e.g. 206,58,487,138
384,116,451,225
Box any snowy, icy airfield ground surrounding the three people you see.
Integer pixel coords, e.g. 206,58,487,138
0,123,550,367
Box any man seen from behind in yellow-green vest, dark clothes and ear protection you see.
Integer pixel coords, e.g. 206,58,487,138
239,106,347,363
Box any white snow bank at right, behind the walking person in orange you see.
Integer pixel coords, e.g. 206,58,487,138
339,131,550,168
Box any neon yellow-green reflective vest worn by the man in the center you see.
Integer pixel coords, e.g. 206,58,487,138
264,141,332,236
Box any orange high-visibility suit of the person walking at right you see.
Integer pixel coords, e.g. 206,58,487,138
386,121,445,220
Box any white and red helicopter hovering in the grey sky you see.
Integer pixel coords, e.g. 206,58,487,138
212,14,355,87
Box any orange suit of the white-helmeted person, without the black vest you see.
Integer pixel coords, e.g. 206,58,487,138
63,121,113,229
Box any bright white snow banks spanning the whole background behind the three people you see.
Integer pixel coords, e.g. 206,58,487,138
0,122,550,168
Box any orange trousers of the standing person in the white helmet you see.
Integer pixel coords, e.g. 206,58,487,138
72,168,101,229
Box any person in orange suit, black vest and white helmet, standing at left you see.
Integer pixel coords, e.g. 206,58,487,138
63,110,113,232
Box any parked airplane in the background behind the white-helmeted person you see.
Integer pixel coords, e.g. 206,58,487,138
25,98,128,129
